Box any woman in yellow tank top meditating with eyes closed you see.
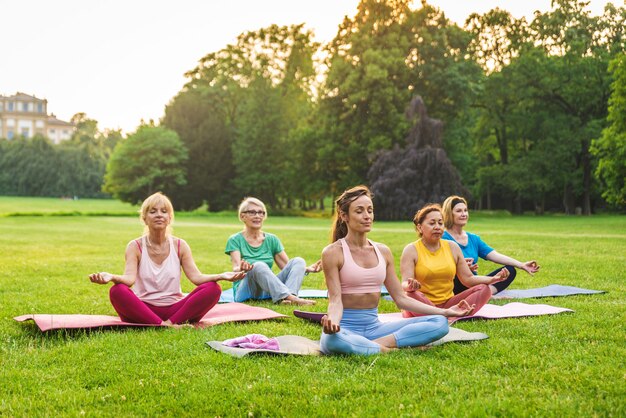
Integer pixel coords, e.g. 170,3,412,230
400,204,509,317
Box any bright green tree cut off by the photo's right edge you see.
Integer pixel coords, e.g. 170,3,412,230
591,53,626,209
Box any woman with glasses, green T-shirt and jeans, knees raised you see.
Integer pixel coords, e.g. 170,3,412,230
225,197,321,305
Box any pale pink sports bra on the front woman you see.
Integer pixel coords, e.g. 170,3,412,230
339,238,387,295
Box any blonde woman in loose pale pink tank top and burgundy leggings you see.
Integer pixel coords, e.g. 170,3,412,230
89,193,245,326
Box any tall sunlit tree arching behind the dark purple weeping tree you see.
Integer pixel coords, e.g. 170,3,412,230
318,0,481,194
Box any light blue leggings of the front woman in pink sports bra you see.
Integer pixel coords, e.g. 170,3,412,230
320,308,448,355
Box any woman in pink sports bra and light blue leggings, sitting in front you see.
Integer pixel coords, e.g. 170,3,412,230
320,186,472,355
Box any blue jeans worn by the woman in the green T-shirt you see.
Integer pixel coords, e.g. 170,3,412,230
235,257,306,303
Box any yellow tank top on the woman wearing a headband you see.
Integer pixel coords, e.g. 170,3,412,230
415,239,456,305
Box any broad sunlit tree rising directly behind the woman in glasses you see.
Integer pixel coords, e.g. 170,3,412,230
179,25,318,206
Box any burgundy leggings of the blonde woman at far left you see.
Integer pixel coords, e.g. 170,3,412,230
109,282,222,325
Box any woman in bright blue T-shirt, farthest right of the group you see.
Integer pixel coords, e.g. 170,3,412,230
441,196,539,295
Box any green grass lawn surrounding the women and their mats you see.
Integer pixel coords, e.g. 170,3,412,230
0,198,626,417
